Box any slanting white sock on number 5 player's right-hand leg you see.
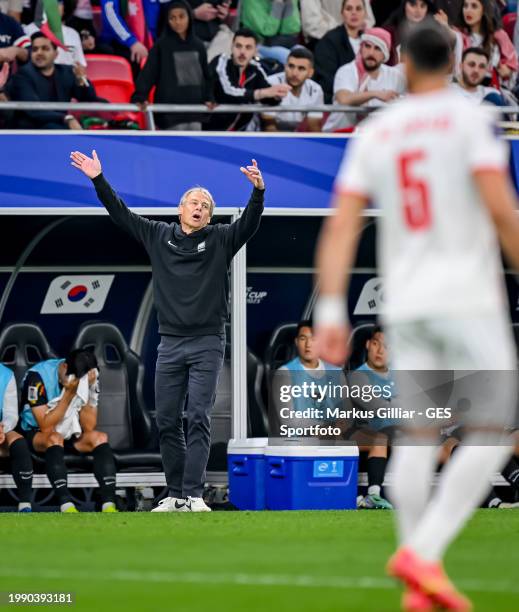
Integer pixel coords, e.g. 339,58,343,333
409,440,512,561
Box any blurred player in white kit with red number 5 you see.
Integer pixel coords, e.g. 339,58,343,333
314,23,519,611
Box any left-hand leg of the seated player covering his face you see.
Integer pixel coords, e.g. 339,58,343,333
31,431,78,513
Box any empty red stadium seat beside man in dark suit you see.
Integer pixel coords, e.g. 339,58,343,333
87,54,135,103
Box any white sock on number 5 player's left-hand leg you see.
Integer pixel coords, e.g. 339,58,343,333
387,444,438,544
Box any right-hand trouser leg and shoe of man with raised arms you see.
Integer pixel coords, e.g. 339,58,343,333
184,334,225,512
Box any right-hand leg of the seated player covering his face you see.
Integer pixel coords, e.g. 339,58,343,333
74,430,117,512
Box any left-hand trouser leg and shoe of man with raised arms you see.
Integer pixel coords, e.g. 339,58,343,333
152,336,188,512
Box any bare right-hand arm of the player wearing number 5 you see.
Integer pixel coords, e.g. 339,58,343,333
474,169,519,271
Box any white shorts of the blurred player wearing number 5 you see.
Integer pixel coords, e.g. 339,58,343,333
386,313,517,432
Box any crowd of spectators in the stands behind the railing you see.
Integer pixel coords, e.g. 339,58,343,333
0,0,519,132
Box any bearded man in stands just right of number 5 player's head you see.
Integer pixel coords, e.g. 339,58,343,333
453,47,505,106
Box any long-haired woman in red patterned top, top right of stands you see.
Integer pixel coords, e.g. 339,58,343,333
455,0,519,89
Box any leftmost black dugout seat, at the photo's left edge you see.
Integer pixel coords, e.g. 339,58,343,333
0,323,56,389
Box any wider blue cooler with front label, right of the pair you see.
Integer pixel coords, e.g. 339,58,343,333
265,446,359,510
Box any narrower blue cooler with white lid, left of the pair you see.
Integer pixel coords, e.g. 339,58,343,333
227,438,268,510
